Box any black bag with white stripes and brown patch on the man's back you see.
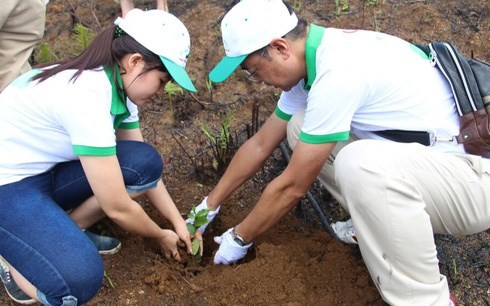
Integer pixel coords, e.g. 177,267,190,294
375,42,490,158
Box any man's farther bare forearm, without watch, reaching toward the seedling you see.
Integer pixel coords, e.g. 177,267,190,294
207,114,287,210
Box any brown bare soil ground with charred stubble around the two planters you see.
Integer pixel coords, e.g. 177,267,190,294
0,0,490,306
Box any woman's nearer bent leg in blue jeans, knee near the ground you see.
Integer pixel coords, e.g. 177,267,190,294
0,173,104,305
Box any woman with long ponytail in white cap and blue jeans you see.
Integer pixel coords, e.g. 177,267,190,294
0,9,195,305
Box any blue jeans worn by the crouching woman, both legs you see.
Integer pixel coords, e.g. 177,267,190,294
0,141,163,305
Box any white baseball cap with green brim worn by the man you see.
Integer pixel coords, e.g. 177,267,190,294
209,0,298,83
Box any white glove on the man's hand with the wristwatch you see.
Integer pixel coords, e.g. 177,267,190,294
214,228,252,265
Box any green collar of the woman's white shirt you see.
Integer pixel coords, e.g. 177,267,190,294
104,66,130,129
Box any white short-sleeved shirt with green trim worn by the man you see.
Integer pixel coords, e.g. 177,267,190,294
276,28,464,153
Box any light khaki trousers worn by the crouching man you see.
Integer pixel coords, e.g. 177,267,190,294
288,109,490,306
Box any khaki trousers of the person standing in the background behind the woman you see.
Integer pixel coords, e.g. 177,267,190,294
0,0,46,92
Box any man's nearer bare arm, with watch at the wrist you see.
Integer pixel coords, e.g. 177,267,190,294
236,141,336,242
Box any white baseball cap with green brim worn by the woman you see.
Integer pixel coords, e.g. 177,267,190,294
114,9,196,92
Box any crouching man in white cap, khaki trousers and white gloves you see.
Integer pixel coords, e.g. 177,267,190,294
189,0,490,305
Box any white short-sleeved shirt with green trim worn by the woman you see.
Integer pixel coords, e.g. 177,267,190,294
0,67,139,186
